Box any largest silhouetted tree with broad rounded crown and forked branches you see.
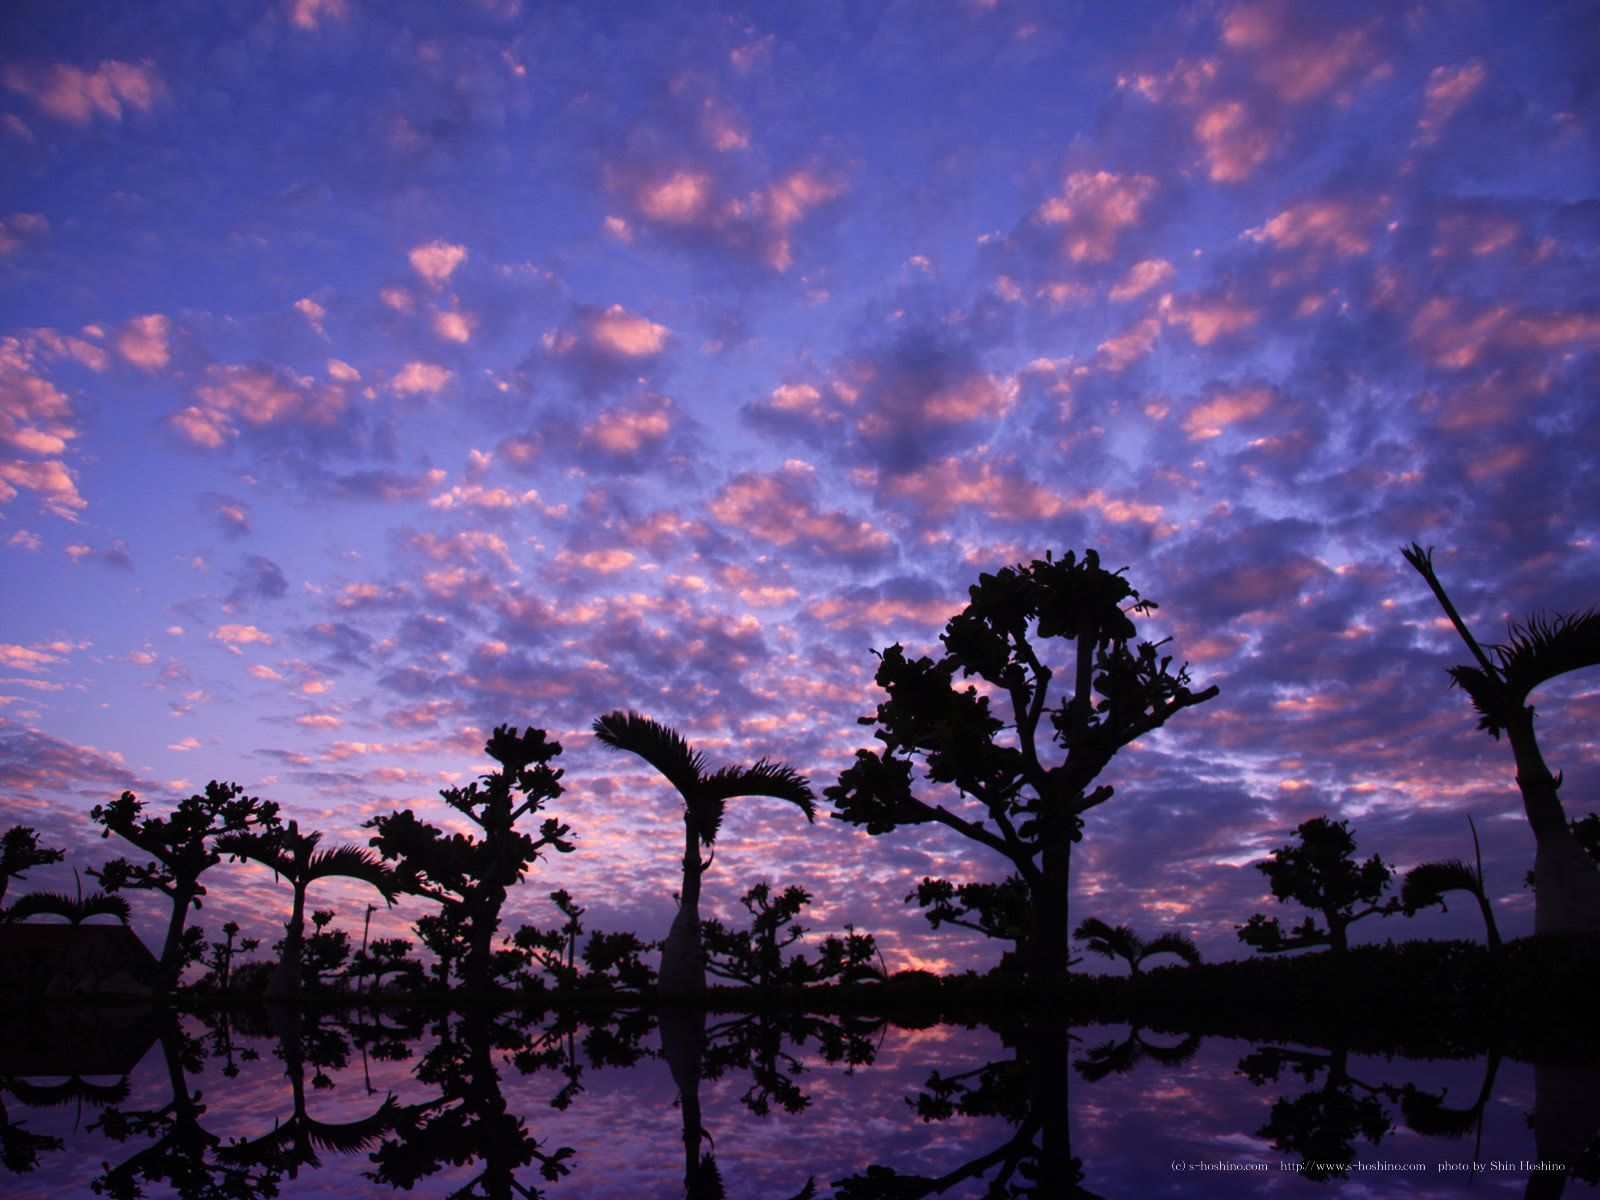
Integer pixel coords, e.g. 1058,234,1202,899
827,550,1218,976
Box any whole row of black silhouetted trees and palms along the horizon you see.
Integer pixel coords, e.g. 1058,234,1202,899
0,546,1600,995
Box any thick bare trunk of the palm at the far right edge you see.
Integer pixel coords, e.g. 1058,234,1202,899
1506,707,1600,934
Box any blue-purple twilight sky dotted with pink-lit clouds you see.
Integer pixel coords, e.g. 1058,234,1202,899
0,0,1600,970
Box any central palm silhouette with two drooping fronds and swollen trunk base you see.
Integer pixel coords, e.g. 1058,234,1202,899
594,710,816,992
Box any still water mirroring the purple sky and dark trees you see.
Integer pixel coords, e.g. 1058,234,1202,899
0,1008,1600,1200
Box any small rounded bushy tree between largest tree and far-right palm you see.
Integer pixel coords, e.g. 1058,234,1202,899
1234,816,1400,954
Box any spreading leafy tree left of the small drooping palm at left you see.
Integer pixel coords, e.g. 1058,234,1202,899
88,779,278,990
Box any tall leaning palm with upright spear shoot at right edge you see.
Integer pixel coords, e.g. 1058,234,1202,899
1402,542,1600,934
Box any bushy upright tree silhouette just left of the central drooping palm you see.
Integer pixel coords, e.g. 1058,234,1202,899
363,725,573,990
